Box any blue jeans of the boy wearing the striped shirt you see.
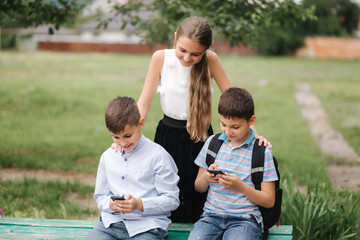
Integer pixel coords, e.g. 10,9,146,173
188,214,262,240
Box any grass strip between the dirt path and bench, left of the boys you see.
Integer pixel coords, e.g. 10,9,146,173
0,179,98,219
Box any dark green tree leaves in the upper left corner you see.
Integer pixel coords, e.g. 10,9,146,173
0,0,91,33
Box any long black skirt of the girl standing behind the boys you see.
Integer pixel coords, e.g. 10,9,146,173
154,116,213,223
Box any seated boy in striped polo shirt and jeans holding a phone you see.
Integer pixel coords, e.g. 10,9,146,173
189,87,278,240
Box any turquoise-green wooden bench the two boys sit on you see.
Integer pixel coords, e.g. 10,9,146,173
0,217,293,240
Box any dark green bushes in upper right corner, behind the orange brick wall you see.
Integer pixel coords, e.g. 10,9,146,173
256,0,360,55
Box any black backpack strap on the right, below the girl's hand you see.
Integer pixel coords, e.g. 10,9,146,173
251,139,265,190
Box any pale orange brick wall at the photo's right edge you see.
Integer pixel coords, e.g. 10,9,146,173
295,37,360,59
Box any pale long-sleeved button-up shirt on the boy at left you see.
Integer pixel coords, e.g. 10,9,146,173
94,136,179,237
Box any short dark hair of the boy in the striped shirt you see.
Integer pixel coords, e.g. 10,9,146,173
218,87,255,121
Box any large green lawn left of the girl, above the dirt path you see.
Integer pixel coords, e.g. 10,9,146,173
0,53,149,172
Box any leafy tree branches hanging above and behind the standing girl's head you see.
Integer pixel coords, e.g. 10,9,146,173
99,0,313,47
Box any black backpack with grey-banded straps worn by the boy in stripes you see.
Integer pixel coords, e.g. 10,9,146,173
206,133,282,239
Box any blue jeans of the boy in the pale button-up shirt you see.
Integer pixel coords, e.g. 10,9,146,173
86,220,168,240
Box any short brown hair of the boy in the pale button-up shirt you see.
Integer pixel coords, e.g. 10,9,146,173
105,97,141,134
